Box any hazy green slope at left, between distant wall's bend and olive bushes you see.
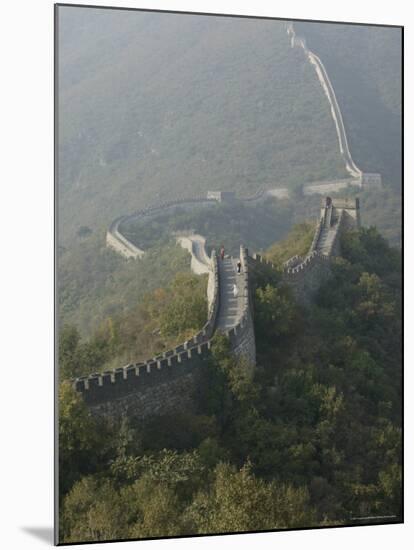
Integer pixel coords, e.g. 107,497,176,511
57,231,195,335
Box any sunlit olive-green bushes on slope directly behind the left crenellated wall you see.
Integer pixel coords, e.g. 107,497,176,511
59,273,207,379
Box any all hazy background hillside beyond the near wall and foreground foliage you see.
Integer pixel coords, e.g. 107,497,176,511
58,7,401,334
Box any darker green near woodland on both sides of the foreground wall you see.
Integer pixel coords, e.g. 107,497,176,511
59,225,402,542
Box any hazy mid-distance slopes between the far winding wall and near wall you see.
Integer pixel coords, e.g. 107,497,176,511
58,189,401,336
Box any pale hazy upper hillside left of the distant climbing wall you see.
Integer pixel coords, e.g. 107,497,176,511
58,8,345,244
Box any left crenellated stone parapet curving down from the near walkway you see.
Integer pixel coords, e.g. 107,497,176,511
73,250,220,418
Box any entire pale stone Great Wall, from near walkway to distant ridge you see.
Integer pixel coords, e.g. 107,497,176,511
73,23,381,419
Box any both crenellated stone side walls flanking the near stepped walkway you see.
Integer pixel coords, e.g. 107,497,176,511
74,239,256,418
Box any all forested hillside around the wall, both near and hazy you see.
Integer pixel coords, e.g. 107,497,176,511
57,7,402,543
